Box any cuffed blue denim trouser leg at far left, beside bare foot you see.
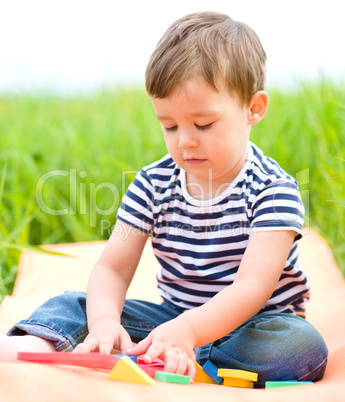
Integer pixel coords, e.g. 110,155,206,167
7,291,88,351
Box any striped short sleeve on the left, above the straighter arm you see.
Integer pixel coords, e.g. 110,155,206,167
117,171,154,234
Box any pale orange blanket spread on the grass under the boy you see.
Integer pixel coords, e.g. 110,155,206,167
0,231,345,402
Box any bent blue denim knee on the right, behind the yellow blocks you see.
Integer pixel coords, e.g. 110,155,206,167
197,314,328,387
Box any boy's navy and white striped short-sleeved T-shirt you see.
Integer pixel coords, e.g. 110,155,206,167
117,142,309,316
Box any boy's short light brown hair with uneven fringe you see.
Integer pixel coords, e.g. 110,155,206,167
146,12,266,103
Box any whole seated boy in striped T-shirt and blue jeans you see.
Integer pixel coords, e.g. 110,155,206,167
2,12,327,387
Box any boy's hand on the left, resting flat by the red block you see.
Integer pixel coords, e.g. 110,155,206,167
74,318,133,354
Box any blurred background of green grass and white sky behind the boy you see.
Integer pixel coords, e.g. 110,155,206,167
0,0,345,301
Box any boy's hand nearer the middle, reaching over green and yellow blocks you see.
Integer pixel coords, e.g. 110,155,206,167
126,316,196,380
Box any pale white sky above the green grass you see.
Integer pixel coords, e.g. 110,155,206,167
0,0,345,93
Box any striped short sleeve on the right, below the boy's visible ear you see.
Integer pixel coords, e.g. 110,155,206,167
250,179,304,240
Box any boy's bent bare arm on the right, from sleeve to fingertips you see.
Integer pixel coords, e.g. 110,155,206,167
130,231,295,377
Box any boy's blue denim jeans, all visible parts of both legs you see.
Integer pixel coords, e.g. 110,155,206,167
8,291,328,387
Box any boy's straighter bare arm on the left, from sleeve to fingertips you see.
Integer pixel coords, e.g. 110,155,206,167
75,219,148,353
